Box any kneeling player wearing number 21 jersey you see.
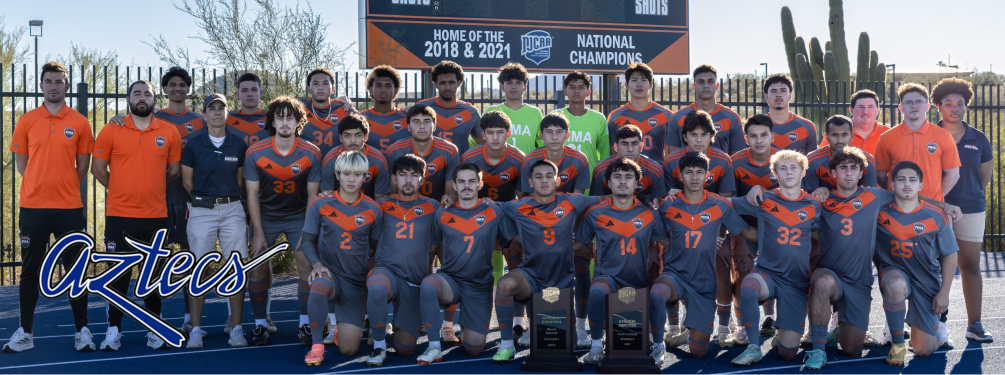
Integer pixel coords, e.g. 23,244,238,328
366,153,439,366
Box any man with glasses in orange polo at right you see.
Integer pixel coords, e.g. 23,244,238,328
874,83,960,201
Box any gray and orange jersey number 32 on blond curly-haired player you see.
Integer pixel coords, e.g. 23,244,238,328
730,189,820,289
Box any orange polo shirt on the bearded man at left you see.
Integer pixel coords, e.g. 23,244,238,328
94,116,182,218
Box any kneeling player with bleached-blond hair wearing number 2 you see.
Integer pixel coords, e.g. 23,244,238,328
300,151,387,366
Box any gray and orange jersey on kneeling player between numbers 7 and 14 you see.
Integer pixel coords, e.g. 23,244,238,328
499,194,600,289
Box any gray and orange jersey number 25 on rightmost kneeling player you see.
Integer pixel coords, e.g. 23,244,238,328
876,202,960,300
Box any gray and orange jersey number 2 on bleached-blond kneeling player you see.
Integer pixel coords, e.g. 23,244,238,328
304,192,379,287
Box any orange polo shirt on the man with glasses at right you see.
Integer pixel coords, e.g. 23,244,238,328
874,121,961,201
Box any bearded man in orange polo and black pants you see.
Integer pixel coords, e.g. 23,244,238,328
90,80,182,351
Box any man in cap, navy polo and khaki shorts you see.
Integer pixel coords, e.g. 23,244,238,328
182,93,248,349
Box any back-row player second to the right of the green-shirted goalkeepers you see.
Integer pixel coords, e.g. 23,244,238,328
666,64,747,155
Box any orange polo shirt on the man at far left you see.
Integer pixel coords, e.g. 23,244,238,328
10,104,94,209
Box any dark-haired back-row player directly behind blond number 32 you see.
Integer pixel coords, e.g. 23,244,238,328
761,73,817,155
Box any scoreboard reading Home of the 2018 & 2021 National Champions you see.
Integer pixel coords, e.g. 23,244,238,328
359,0,690,74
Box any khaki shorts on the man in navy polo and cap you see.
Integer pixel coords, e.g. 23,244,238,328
188,202,248,261
